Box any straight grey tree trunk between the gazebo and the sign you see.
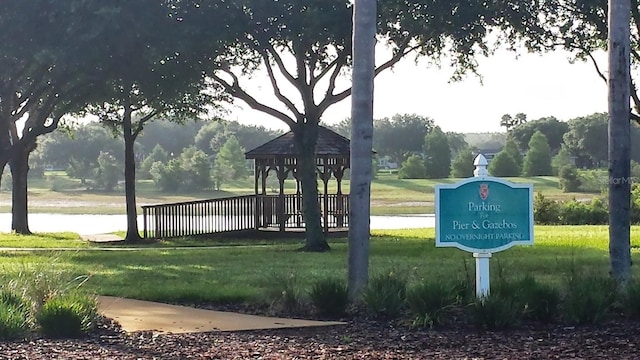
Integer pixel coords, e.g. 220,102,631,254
348,0,377,299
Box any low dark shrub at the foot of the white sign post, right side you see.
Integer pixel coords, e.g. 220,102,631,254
471,292,522,330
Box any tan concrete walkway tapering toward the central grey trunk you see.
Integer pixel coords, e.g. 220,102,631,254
98,296,345,334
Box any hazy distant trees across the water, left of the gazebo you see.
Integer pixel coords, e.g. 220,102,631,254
5,119,281,192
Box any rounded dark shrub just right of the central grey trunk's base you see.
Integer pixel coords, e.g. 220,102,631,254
362,272,407,317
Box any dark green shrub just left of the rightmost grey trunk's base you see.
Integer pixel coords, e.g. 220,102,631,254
564,273,617,325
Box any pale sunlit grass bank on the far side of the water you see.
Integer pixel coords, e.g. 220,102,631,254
0,172,598,215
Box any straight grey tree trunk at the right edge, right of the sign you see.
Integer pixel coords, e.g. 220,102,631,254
608,0,631,285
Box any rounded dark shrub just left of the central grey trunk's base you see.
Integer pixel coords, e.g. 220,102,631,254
309,278,349,317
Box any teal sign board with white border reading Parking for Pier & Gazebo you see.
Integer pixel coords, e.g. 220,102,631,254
435,177,533,253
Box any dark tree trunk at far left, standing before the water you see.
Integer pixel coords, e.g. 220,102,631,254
9,144,31,235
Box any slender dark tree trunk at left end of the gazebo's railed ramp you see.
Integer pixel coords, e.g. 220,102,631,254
122,107,141,243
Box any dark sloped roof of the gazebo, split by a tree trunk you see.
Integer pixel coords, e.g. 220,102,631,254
244,126,350,159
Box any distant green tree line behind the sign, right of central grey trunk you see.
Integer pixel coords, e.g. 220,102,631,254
374,113,640,181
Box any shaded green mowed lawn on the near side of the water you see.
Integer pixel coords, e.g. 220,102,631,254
0,226,640,303
